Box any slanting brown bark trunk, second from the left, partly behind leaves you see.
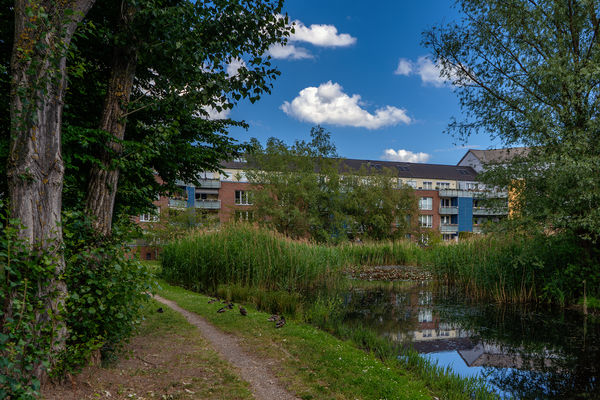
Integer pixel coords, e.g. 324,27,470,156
86,7,137,236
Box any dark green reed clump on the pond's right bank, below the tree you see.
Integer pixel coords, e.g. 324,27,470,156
424,235,586,304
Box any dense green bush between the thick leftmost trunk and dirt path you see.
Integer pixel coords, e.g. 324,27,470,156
53,212,152,377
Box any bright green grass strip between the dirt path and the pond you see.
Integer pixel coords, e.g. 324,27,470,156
158,282,495,399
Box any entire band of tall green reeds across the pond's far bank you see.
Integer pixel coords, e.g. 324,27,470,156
162,224,600,304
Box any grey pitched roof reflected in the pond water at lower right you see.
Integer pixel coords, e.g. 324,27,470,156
458,342,557,370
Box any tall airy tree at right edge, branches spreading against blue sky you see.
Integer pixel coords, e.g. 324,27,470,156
424,0,600,247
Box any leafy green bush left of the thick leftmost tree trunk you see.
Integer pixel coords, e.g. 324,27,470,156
0,220,56,399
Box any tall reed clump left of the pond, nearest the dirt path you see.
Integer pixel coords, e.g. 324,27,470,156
162,225,344,292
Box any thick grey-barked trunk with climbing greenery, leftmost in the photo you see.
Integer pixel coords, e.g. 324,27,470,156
7,0,94,381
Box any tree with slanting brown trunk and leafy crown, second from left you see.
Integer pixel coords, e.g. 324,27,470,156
75,0,291,236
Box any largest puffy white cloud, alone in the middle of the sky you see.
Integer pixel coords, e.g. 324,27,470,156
281,81,411,129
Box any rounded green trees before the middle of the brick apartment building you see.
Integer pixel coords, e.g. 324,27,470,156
246,126,416,242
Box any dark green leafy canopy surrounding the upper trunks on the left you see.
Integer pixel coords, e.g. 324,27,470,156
0,0,291,222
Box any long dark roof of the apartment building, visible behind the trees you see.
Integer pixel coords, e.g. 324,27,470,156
222,158,477,181
